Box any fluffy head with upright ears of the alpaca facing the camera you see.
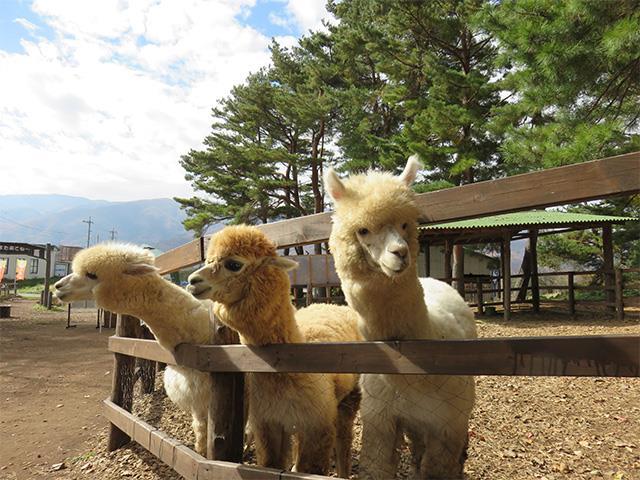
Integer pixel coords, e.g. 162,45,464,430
324,155,421,278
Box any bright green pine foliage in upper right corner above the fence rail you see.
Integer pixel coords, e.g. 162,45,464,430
484,0,640,173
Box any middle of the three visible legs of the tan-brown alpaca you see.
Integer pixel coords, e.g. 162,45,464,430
295,422,336,475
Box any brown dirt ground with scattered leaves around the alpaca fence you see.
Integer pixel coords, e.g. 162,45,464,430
0,300,640,480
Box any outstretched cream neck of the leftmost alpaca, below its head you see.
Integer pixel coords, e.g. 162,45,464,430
100,275,209,350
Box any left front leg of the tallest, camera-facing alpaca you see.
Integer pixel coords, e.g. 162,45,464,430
358,416,403,480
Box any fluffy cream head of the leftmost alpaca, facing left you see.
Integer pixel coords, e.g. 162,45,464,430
54,243,157,302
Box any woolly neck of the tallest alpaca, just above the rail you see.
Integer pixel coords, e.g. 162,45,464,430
342,267,434,340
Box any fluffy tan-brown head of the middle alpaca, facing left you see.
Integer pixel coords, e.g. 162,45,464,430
187,225,298,305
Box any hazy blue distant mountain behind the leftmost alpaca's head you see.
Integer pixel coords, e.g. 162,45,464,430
0,195,192,251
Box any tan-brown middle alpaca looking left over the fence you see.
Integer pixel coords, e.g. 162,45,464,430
189,226,360,477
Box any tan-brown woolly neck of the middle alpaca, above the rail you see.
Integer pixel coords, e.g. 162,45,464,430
222,290,304,345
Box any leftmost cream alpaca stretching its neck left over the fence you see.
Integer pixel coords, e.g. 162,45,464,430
55,243,212,455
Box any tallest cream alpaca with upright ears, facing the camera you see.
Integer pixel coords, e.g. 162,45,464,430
324,157,476,479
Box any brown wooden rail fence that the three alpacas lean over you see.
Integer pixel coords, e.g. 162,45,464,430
105,152,640,480
